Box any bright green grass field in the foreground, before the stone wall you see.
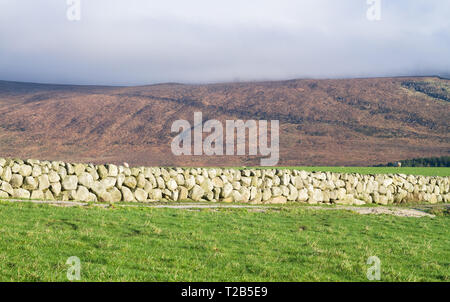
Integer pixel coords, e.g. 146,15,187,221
0,201,450,281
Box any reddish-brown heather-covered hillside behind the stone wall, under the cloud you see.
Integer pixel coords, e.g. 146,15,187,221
0,77,450,166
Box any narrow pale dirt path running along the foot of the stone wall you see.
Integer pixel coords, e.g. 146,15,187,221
1,199,442,217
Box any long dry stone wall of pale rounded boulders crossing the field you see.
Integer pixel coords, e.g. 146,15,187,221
0,158,450,205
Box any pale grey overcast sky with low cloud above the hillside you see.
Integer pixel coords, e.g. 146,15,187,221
0,0,450,85
